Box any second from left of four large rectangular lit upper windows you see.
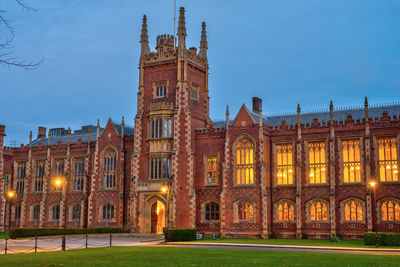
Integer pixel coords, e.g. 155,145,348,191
308,142,326,184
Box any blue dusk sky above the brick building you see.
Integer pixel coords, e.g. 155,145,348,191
0,0,400,145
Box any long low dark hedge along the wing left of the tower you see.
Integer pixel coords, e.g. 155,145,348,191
8,228,123,241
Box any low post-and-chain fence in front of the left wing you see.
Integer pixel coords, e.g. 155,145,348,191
0,234,125,255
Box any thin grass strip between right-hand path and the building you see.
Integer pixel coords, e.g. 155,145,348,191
192,238,400,248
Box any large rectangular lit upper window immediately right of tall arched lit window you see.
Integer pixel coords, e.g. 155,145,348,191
275,144,294,185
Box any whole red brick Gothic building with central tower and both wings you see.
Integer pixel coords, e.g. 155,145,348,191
0,9,400,238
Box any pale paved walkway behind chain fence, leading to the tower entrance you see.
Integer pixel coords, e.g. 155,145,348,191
0,234,163,254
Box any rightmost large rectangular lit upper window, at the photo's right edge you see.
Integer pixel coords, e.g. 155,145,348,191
378,137,399,182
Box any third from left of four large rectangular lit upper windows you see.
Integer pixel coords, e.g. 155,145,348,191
342,140,361,183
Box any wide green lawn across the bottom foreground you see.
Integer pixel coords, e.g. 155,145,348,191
0,247,400,266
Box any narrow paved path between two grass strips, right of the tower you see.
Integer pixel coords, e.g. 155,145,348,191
160,242,400,256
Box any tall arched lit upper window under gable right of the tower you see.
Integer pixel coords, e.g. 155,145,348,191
236,137,254,185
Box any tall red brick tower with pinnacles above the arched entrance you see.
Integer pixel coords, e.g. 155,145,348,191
130,7,210,232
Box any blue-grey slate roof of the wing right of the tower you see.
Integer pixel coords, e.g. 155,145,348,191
213,103,400,127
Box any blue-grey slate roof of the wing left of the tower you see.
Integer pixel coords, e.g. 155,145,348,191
32,122,134,146
